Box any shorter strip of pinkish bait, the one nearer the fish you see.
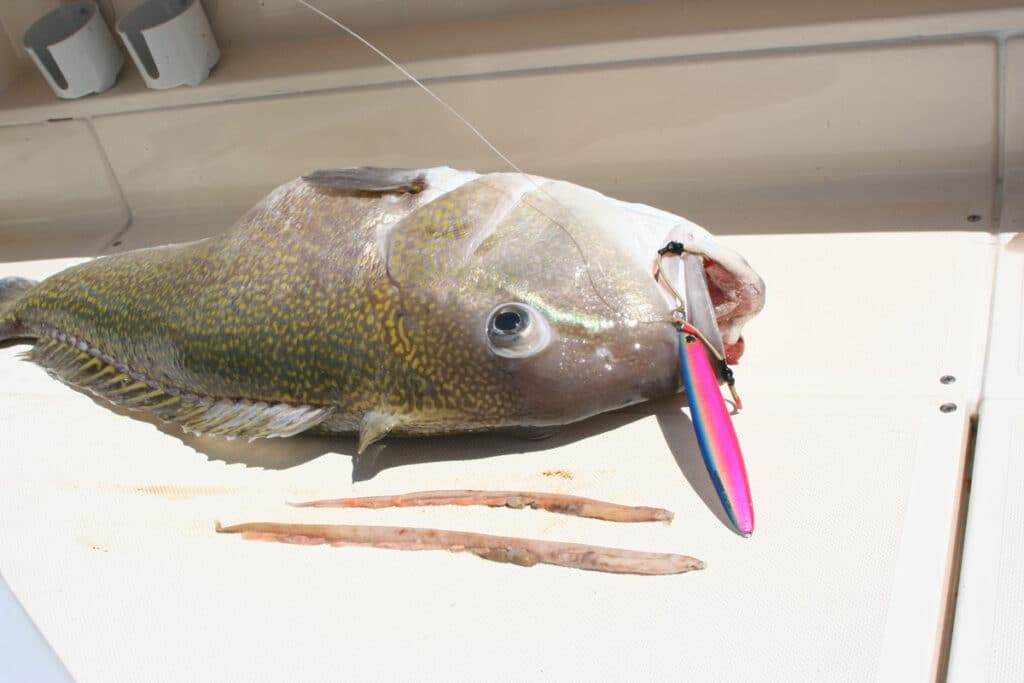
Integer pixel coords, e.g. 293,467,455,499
290,489,673,522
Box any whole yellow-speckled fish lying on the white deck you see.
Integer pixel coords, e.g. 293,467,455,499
0,168,764,450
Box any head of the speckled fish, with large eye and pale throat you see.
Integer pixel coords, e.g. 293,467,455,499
386,174,760,428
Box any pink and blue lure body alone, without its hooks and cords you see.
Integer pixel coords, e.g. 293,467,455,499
679,323,754,536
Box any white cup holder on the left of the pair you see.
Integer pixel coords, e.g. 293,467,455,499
23,0,124,99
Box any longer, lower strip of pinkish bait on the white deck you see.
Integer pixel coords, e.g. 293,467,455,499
217,522,705,574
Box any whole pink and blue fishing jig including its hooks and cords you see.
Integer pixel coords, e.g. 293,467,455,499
656,242,754,537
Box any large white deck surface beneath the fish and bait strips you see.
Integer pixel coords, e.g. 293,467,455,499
0,228,995,681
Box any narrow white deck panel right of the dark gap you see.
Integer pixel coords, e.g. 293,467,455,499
949,234,1024,682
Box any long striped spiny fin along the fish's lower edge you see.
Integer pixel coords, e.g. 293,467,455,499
26,336,333,440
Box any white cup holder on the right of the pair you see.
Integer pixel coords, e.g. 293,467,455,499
118,0,220,90
